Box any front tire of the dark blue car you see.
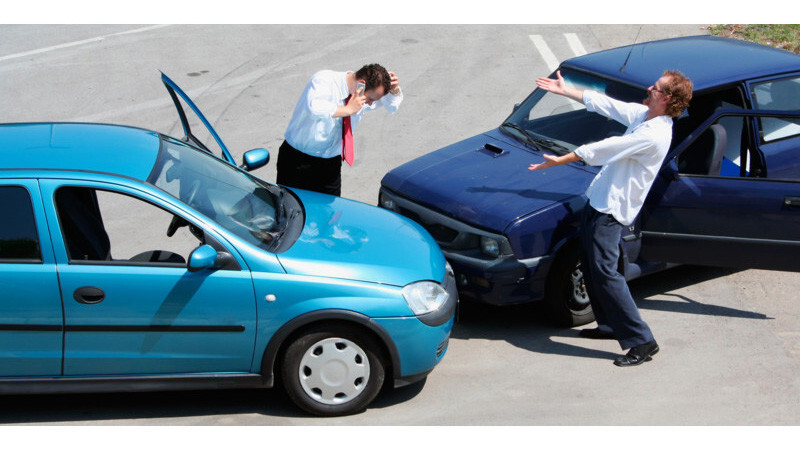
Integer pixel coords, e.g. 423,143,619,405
545,242,594,327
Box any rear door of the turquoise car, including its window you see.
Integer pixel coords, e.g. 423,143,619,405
0,179,63,377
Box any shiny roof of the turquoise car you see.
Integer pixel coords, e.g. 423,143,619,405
0,123,161,180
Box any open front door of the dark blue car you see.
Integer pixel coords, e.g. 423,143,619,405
641,98,800,271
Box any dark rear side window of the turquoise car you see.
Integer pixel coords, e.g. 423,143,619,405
0,186,42,264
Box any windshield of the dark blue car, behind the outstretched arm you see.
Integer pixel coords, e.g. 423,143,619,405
501,68,646,154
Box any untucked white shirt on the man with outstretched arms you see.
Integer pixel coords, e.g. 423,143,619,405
575,90,672,226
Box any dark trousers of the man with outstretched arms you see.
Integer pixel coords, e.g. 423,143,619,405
580,203,653,349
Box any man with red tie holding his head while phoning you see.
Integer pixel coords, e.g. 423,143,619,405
276,64,403,196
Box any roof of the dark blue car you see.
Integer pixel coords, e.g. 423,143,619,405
562,36,800,91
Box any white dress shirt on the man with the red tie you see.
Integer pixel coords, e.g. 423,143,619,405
284,70,403,158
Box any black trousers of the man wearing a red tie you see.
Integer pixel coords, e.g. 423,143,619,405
275,141,342,196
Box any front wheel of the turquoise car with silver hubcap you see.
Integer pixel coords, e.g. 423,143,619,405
281,325,386,416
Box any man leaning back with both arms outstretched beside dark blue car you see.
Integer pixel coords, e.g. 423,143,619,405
528,71,692,367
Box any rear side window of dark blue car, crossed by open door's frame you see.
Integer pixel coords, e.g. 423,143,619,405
752,77,800,144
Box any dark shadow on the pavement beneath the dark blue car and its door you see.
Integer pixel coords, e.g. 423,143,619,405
451,266,771,359
